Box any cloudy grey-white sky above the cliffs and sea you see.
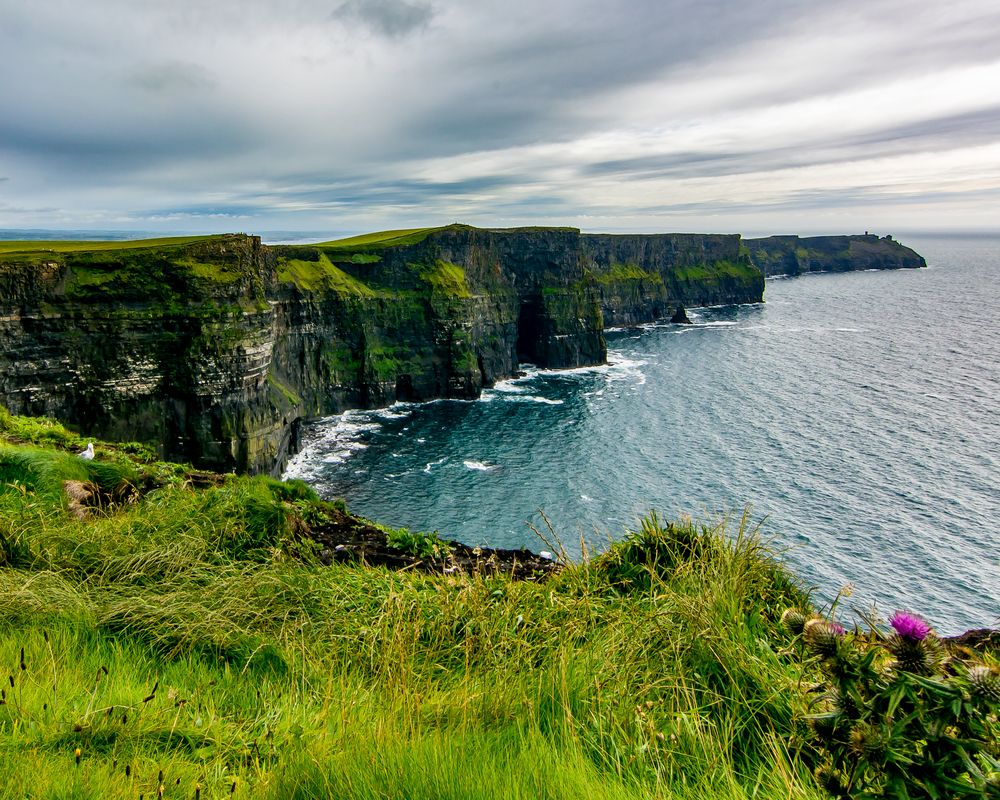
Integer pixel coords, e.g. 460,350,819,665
0,0,1000,235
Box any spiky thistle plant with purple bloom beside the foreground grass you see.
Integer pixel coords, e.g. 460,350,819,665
782,609,1000,800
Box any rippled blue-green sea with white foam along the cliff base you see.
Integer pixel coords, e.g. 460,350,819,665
288,237,1000,632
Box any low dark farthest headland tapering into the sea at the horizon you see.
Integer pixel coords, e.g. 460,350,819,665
743,233,927,278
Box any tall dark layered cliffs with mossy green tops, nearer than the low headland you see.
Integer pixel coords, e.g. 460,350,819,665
0,225,912,472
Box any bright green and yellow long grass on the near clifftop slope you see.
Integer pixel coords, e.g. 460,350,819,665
0,411,823,800
